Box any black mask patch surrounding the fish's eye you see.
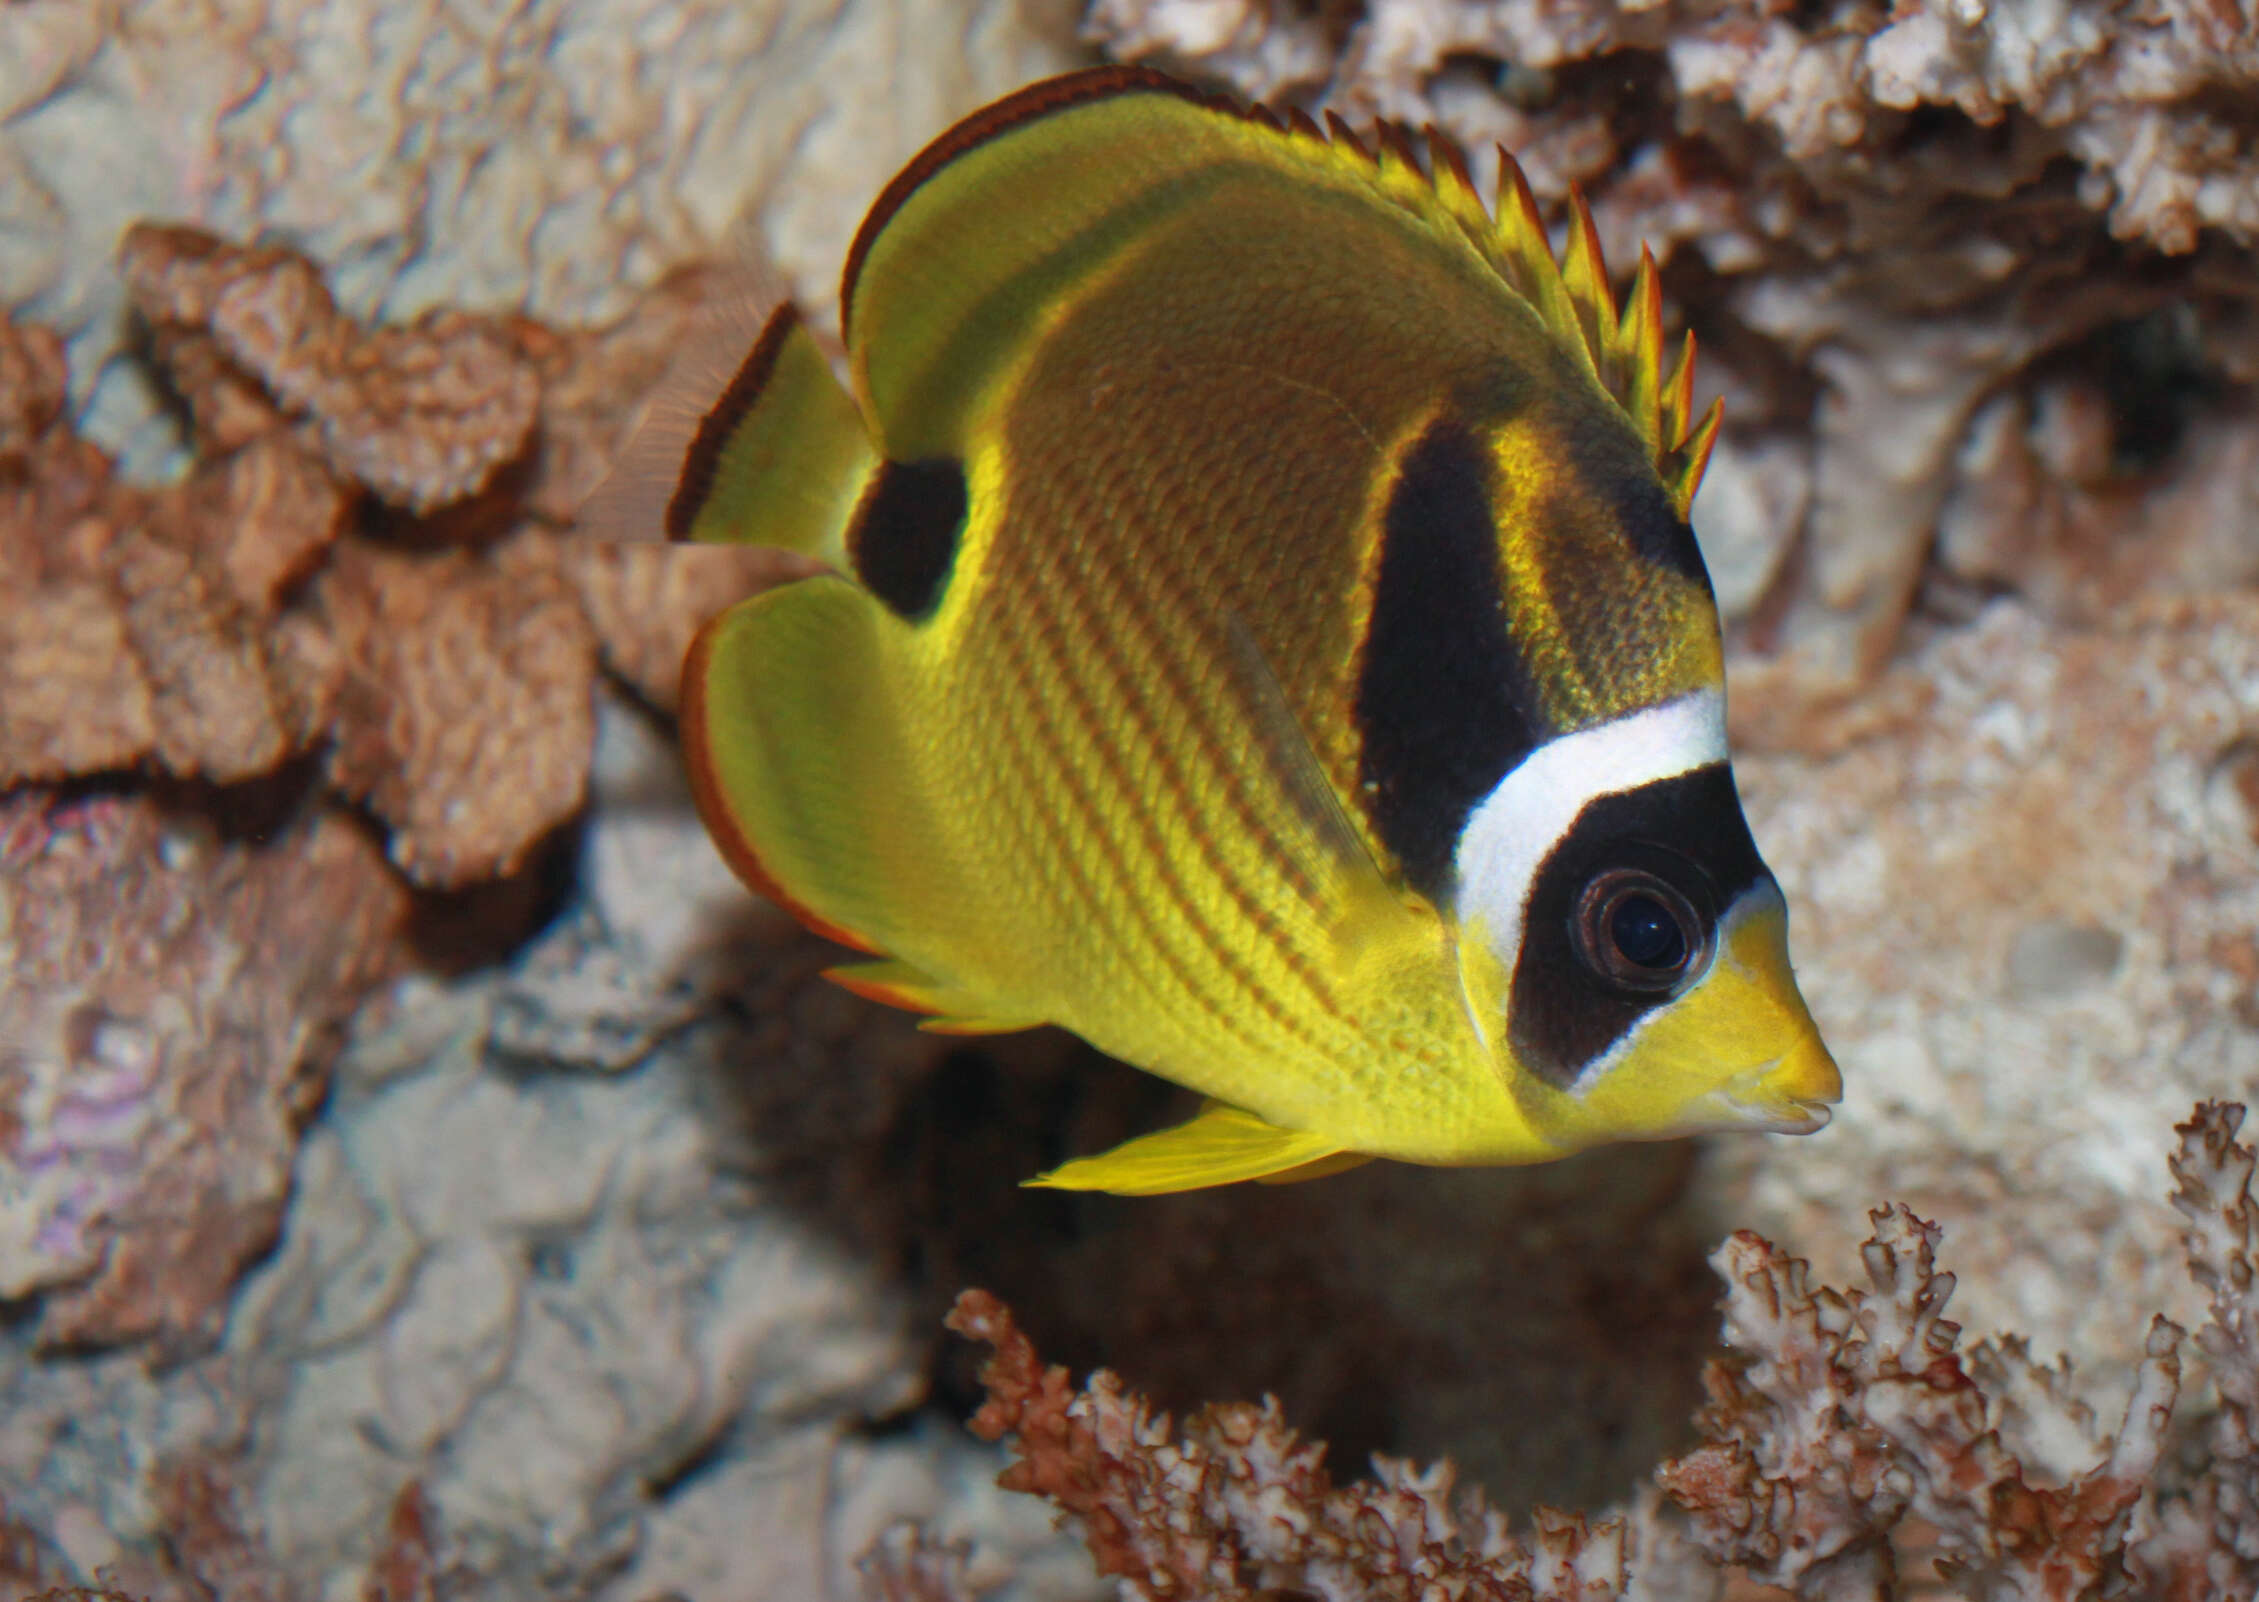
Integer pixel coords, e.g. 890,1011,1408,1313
1507,761,1767,1085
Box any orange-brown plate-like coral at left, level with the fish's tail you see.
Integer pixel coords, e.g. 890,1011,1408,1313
0,226,773,886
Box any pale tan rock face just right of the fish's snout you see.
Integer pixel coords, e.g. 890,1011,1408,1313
1706,592,2259,1378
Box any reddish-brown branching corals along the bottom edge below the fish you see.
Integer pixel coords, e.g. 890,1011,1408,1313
944,1103,2259,1602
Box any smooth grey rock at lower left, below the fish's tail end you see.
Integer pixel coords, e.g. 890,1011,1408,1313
0,707,1089,1602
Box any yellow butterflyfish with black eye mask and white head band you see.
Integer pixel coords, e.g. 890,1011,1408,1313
600,68,1841,1193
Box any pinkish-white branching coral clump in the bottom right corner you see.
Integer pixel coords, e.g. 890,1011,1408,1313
1663,1103,2259,1600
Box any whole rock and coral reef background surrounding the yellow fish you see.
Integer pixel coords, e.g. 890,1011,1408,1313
0,0,2259,1602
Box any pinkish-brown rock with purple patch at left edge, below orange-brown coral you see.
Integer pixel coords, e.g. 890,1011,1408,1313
0,791,407,1349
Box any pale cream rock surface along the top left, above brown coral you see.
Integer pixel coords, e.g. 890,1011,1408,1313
0,0,1075,472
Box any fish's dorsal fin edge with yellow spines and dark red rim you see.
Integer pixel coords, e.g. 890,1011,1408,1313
840,66,1719,517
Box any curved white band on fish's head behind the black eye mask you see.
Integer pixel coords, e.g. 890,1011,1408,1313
1457,689,1726,969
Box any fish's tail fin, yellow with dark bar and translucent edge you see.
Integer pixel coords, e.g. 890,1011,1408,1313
581,301,876,567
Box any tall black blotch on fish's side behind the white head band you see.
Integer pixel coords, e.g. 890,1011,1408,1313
1355,420,1538,899
